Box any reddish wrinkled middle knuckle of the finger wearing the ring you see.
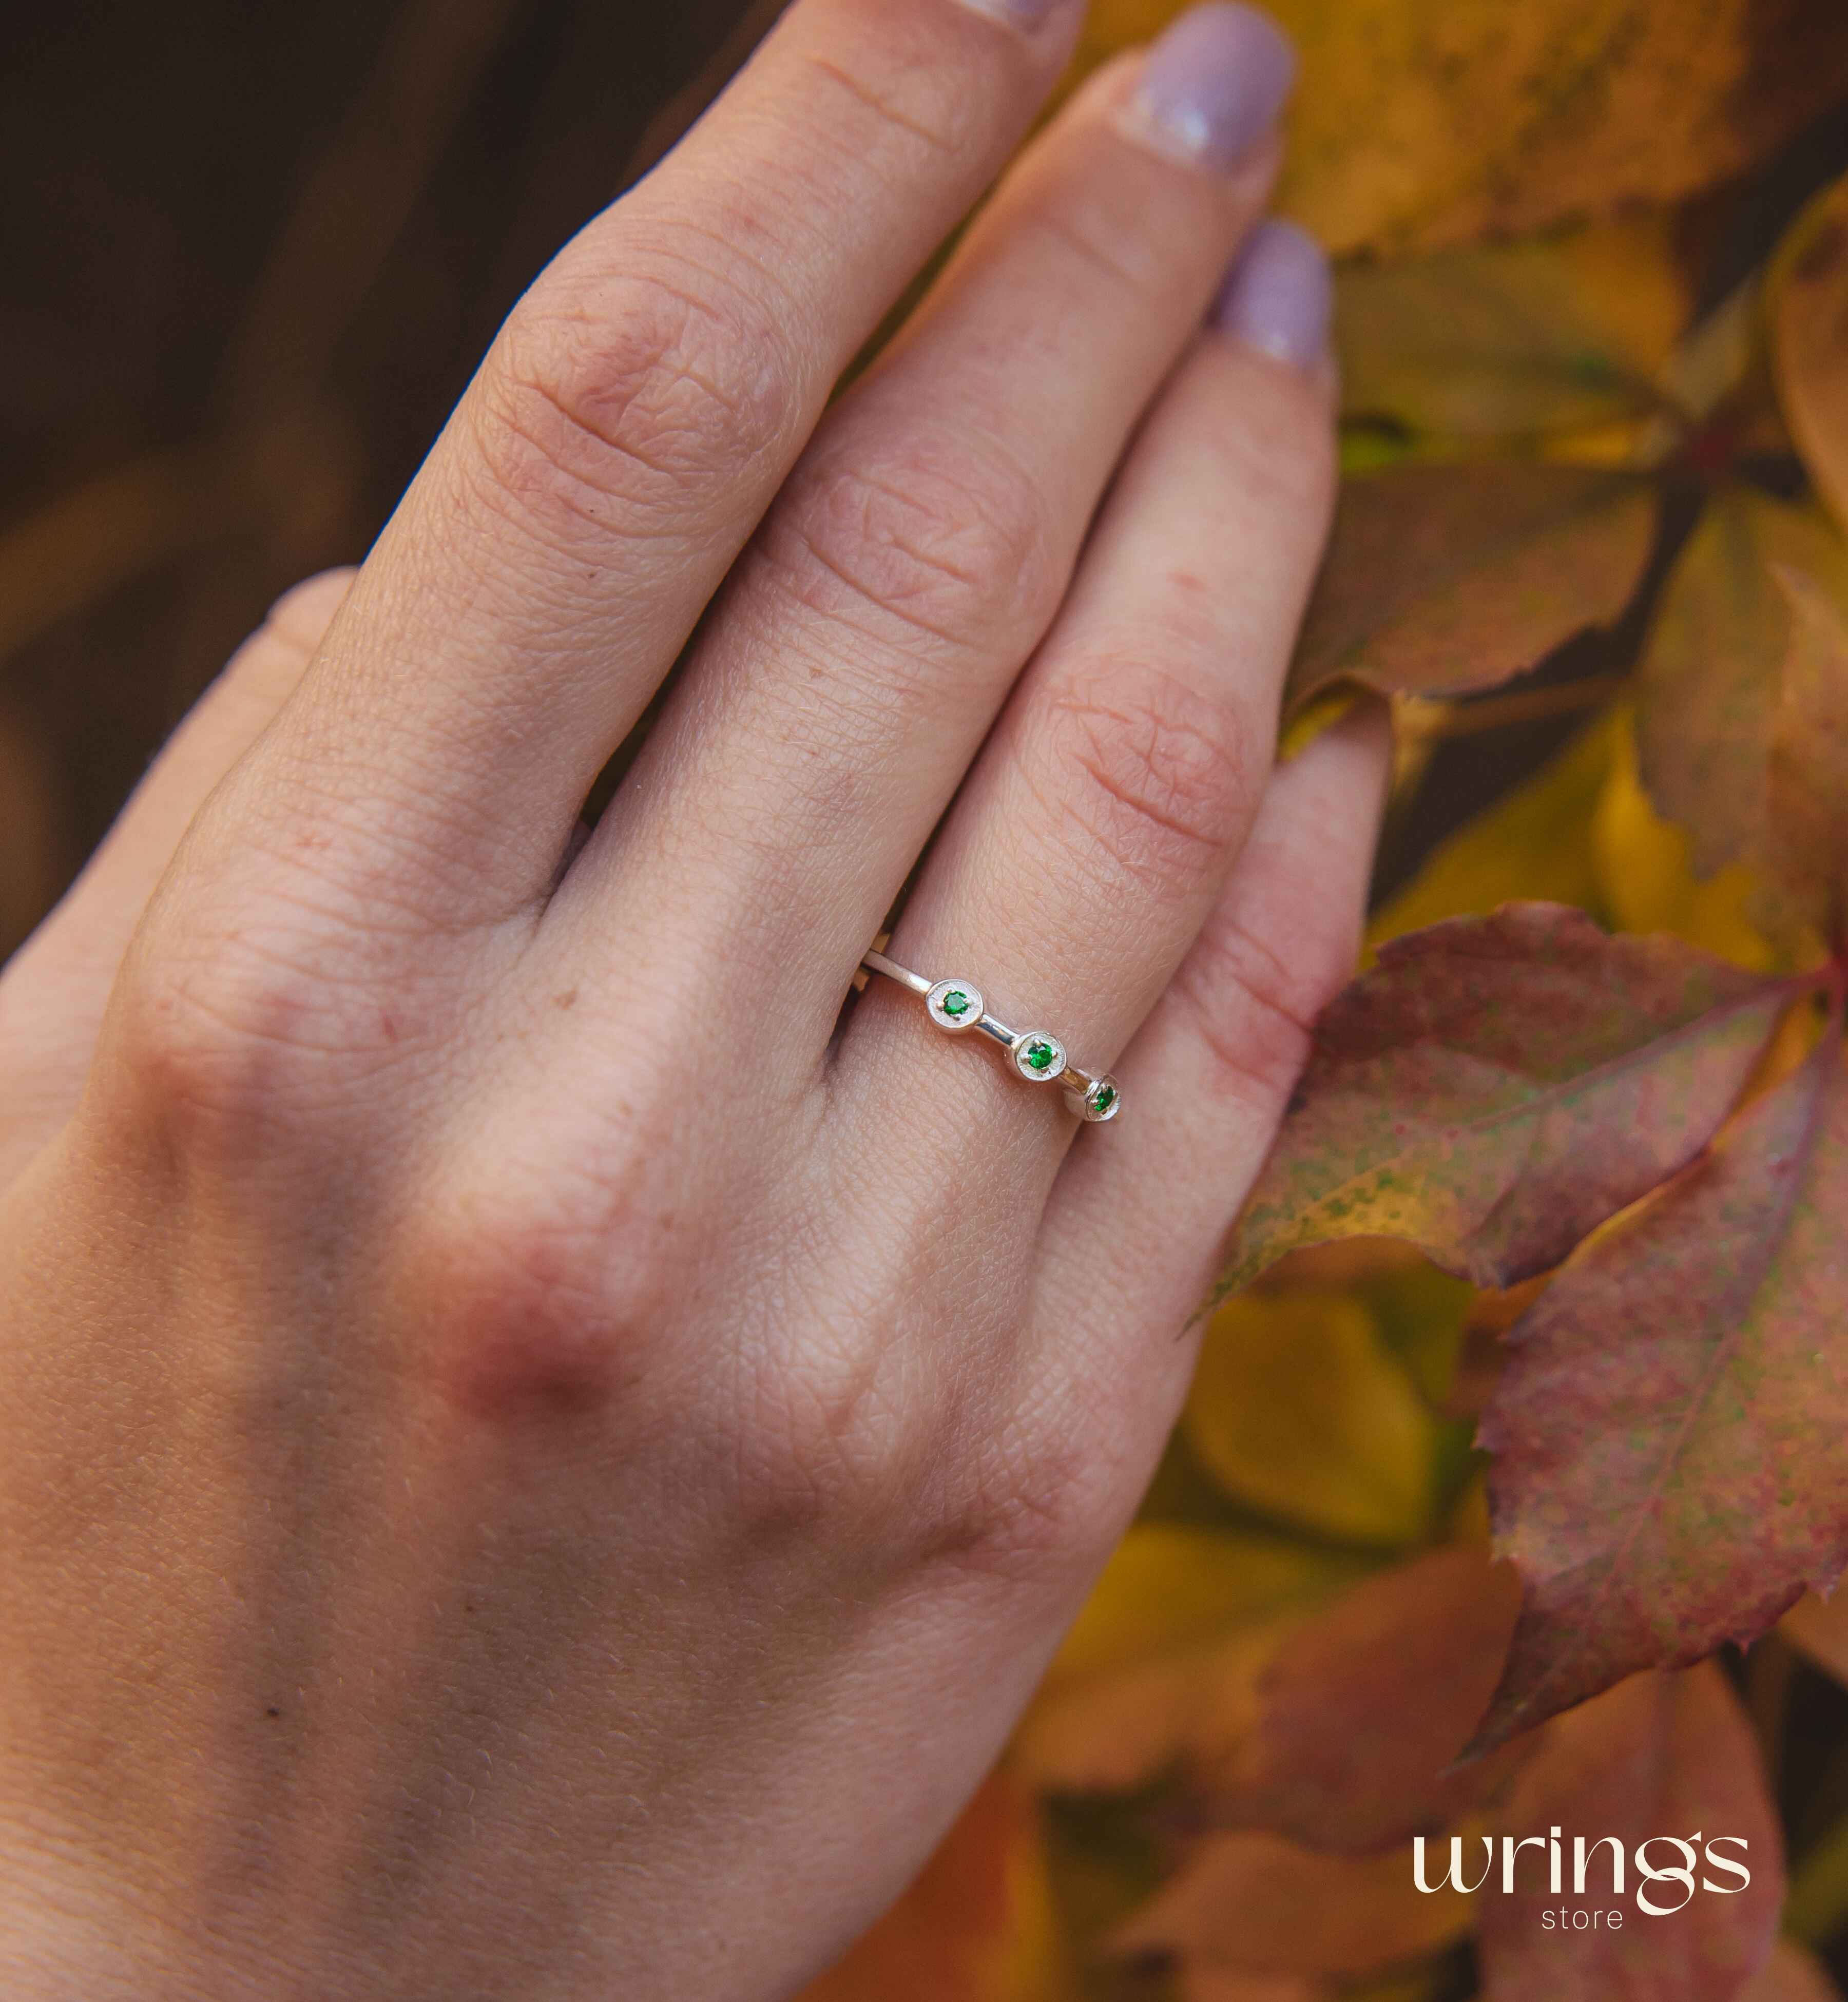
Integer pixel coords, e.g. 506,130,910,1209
1027,663,1256,885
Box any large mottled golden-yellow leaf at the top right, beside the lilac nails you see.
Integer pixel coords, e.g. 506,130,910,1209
1079,0,1848,251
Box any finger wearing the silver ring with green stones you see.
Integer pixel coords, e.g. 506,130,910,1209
843,222,1334,1171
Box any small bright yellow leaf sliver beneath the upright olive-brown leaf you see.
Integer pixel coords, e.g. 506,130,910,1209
1592,711,1776,971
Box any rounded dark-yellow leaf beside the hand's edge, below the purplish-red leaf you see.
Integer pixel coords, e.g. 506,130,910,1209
1183,1293,1436,1546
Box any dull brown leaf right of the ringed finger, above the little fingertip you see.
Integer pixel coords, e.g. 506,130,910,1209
1287,460,1656,705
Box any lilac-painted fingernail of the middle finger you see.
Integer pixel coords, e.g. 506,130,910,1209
1135,0,1296,166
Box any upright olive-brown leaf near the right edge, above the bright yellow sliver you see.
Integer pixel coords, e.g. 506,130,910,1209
1636,487,1848,877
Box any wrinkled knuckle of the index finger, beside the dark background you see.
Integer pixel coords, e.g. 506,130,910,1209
467,274,795,525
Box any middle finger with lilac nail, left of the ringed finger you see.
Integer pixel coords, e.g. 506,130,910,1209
552,6,1292,1053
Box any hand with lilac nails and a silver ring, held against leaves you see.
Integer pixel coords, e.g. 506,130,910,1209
0,0,1383,2002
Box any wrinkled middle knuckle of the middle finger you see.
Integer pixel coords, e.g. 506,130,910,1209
765,434,1053,651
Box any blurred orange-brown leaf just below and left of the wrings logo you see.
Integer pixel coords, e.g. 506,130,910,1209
1111,1832,1474,1974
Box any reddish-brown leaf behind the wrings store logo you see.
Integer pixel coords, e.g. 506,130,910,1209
1479,1664,1784,2002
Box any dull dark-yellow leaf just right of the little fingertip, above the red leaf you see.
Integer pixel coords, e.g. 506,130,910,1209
1368,717,1620,947
